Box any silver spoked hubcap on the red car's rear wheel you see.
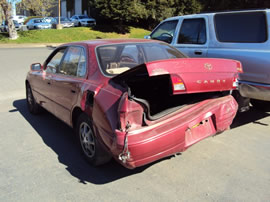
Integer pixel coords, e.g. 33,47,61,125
80,122,95,158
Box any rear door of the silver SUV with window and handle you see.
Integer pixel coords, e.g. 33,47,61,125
172,17,208,57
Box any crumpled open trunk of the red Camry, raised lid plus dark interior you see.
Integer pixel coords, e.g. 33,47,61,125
112,58,241,121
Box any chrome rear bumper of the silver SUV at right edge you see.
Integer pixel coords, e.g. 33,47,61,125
239,81,270,101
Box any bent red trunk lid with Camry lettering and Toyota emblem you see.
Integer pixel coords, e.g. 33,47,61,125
112,58,242,94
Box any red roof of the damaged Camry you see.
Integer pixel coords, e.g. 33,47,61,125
62,39,163,47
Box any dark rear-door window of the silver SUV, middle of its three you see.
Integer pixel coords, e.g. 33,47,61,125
178,18,206,44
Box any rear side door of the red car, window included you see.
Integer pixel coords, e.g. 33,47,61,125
48,46,87,124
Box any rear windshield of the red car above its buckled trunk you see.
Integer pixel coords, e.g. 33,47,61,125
97,43,186,76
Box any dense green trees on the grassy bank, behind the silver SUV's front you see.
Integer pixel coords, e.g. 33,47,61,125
90,0,201,28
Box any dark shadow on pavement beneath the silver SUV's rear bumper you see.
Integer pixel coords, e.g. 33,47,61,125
231,107,270,129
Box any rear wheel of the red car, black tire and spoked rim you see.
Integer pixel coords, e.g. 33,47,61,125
76,113,111,166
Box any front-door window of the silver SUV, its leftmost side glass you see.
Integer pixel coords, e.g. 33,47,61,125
151,20,178,43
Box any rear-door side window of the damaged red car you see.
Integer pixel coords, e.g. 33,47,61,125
59,47,86,77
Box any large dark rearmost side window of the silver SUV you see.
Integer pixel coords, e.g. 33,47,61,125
215,12,267,43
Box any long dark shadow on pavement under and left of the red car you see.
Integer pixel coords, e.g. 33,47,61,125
10,99,170,184
